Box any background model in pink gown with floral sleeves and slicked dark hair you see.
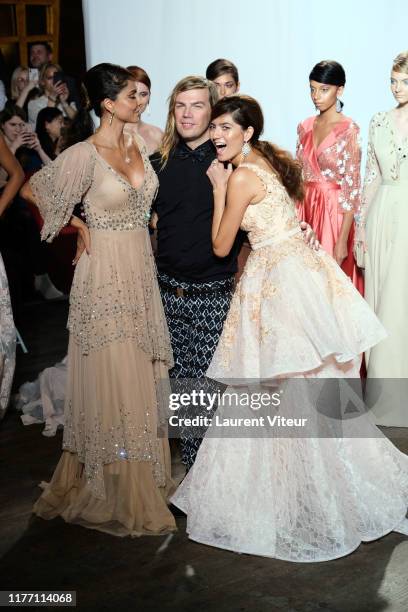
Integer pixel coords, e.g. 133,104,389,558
297,61,363,293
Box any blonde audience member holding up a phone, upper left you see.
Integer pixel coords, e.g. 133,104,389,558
28,64,76,126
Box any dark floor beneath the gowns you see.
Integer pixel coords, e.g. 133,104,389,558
0,302,408,612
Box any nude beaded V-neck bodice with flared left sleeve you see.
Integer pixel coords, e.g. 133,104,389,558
30,135,158,241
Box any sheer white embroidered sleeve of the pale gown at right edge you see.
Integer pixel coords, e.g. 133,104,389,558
356,117,381,242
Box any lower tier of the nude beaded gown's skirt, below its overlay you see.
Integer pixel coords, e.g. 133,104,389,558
34,339,175,536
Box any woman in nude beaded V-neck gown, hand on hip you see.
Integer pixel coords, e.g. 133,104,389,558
23,64,175,536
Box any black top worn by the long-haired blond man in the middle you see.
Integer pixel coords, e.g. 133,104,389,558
150,140,242,282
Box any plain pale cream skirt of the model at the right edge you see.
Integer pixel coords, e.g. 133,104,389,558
365,181,408,427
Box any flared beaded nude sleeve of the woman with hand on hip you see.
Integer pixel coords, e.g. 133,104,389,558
30,142,95,242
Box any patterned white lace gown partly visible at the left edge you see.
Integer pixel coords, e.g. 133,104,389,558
0,255,16,419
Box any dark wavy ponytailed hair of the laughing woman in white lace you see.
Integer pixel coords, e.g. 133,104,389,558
211,96,304,200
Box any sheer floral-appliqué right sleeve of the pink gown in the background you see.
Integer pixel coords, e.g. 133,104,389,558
337,123,361,213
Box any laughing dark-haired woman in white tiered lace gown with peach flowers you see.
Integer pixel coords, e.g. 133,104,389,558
172,97,408,562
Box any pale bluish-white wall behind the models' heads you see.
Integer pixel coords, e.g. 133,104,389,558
83,0,408,157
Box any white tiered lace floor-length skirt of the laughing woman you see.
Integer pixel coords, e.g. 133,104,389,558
172,241,408,562
